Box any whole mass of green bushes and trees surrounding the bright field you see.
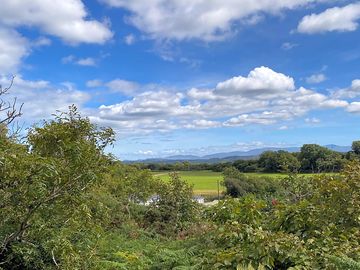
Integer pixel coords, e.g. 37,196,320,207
0,100,360,270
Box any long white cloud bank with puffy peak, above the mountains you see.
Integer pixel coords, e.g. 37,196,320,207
88,67,349,133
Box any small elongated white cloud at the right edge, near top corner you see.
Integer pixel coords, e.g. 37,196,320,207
297,2,360,34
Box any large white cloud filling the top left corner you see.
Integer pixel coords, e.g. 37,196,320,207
0,0,113,44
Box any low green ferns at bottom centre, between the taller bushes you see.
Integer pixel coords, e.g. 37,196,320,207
97,228,201,270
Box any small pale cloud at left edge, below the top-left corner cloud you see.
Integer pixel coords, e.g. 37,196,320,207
0,27,30,74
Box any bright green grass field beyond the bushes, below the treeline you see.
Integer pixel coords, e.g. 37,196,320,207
153,171,330,195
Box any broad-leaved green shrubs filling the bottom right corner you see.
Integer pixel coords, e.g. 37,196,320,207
197,163,360,269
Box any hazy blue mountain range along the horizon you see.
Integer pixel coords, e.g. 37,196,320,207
124,144,351,163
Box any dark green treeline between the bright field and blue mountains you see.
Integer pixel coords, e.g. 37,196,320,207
138,141,360,173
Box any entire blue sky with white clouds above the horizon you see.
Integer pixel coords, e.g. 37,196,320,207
0,0,360,160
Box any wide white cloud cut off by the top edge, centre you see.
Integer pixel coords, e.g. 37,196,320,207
102,0,321,41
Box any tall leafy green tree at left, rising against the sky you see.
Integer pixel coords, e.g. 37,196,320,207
0,106,114,269
